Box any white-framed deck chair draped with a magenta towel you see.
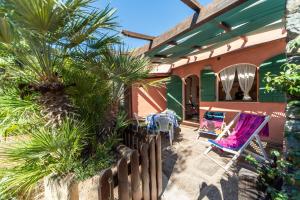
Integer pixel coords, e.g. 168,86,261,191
204,113,270,171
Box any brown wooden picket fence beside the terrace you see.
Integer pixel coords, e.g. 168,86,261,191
99,132,162,200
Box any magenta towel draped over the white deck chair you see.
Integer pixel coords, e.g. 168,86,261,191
212,113,269,149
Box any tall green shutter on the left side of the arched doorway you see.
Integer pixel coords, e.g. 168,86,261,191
167,75,183,119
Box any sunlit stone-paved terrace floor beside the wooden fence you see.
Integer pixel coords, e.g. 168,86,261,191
162,126,280,200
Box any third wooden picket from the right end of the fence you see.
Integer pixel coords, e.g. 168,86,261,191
141,143,150,200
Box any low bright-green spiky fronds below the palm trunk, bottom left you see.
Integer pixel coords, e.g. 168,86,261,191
0,120,89,196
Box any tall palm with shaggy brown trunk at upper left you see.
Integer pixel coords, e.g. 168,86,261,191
0,0,116,124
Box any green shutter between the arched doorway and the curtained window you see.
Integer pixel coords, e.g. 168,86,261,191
200,70,216,101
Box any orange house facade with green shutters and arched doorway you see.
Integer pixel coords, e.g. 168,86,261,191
127,1,286,144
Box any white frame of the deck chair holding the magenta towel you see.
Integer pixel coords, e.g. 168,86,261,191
204,113,270,171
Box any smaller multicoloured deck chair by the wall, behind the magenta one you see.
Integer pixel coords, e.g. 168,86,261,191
198,111,226,139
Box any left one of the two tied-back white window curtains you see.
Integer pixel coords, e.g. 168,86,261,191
220,66,236,100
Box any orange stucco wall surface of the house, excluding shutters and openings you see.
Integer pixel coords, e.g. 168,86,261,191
133,38,286,143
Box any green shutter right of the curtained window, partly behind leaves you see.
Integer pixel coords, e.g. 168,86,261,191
259,54,286,102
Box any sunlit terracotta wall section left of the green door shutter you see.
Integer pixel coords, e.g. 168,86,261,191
132,78,167,117
